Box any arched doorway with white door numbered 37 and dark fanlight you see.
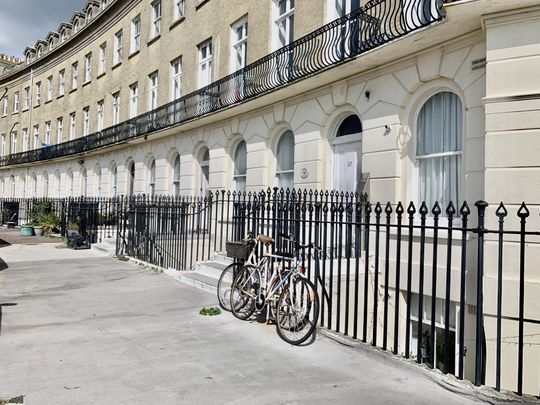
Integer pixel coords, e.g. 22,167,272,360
332,114,362,192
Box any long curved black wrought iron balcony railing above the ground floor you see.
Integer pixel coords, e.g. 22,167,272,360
0,0,450,166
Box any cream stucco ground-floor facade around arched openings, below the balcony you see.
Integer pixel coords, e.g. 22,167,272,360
0,0,540,393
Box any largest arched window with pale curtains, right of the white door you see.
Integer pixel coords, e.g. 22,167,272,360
416,91,463,208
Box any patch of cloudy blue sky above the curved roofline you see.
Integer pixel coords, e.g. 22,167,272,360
0,0,86,58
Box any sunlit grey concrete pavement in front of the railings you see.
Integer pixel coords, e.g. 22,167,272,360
0,244,506,405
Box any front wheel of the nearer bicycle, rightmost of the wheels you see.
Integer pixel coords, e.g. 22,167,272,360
276,277,319,345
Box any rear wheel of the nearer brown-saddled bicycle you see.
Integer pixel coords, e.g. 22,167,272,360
230,266,261,320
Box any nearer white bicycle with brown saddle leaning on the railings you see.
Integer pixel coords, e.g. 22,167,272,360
230,235,320,345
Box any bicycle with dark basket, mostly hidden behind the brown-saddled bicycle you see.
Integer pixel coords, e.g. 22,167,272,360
217,232,256,311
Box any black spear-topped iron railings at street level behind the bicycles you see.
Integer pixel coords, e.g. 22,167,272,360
2,189,540,395
